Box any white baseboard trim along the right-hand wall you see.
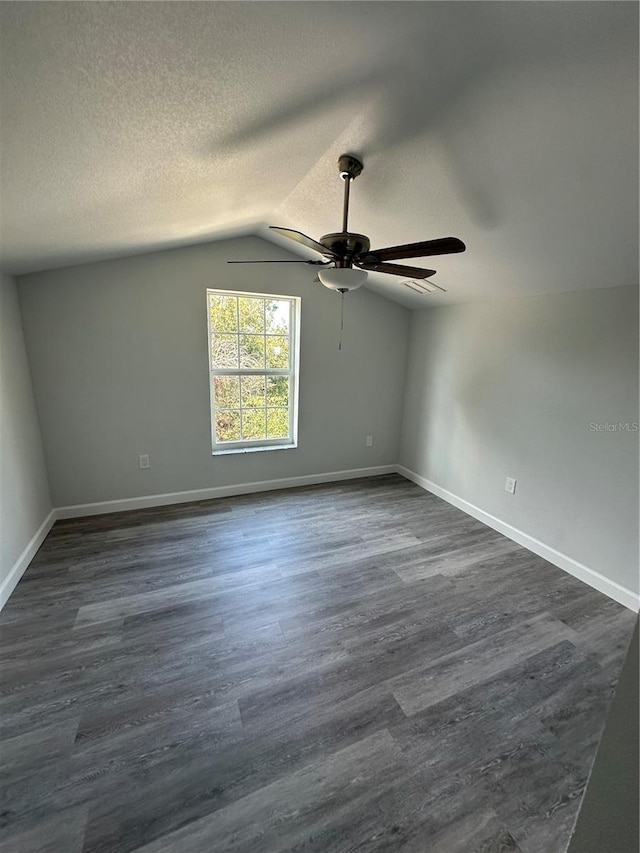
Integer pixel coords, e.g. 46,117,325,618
396,465,640,613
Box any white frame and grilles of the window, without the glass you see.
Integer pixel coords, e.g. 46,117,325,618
206,287,301,456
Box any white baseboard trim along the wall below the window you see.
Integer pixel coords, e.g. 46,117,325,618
56,465,397,518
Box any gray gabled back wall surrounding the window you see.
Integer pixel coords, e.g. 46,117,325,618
19,238,409,507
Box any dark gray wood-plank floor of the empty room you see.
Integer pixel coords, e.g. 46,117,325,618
0,475,635,853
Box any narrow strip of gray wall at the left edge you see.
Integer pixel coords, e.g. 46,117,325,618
0,274,51,588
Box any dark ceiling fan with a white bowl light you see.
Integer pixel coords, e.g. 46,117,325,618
227,154,466,294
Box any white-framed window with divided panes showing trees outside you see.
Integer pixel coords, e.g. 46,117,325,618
207,290,300,453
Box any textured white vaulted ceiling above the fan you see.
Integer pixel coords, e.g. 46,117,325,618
0,2,638,307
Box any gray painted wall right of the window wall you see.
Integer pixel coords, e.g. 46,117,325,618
400,287,639,591
